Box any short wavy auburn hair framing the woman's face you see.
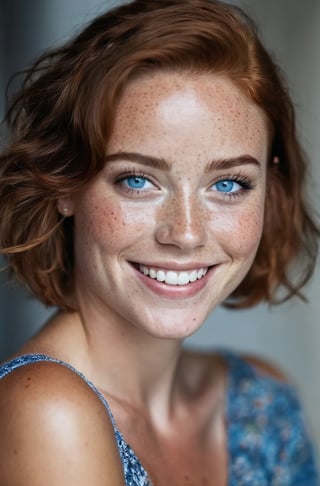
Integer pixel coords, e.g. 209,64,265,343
0,0,319,310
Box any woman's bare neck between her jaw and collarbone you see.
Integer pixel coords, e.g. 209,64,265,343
70,312,182,416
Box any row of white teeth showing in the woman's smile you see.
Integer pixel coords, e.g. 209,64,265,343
138,265,208,285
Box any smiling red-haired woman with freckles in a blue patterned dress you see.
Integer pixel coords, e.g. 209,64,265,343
0,0,319,486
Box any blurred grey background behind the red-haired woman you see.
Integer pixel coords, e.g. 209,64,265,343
0,0,320,451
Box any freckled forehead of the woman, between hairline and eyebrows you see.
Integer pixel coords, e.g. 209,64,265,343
109,72,268,162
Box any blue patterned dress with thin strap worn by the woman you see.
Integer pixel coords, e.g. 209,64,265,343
0,351,320,486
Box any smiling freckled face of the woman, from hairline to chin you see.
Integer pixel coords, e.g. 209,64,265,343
71,73,268,338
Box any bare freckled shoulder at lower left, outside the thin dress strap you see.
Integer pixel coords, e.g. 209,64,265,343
0,362,124,486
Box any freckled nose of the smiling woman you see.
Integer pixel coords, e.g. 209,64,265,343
156,194,208,250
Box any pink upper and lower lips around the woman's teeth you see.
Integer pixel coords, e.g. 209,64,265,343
130,262,216,299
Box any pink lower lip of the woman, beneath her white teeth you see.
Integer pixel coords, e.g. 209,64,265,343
133,266,214,299
